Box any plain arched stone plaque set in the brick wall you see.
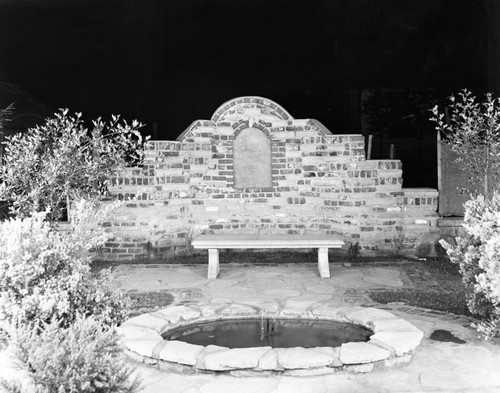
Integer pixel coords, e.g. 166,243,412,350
233,128,272,188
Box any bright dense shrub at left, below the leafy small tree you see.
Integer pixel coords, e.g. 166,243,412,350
0,201,128,326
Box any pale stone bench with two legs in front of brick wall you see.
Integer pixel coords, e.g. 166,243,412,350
192,235,344,278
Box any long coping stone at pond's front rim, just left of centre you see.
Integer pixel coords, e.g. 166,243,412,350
205,347,271,371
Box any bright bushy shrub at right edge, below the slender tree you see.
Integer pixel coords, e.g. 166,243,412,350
441,193,500,338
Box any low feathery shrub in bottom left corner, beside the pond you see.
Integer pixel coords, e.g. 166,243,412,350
6,316,140,393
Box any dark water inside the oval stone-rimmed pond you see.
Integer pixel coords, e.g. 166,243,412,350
163,318,373,348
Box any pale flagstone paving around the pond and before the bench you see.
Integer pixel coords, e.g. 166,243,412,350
0,263,500,393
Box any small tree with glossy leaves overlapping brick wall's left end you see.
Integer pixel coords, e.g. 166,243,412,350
0,109,143,220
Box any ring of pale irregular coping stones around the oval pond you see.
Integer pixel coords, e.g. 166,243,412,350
117,304,423,376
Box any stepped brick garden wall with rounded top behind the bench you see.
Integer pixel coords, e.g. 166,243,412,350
103,97,438,259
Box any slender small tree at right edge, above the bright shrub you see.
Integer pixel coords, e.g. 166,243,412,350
430,90,500,200
